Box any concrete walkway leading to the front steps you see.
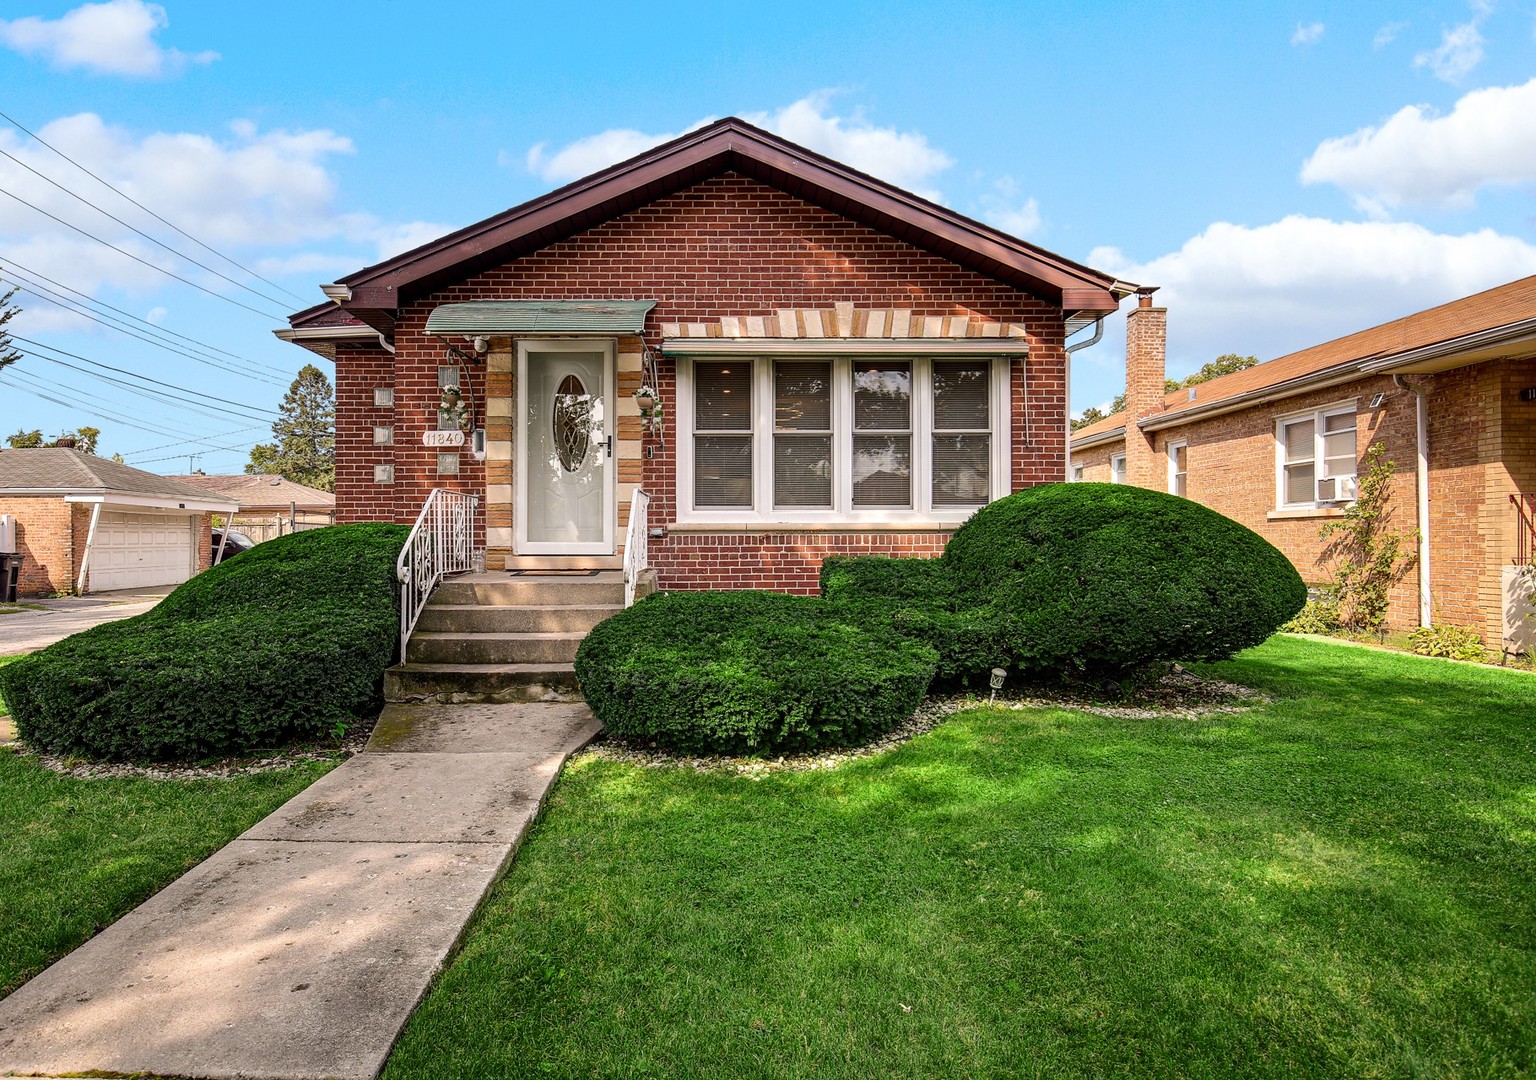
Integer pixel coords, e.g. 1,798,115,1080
0,702,601,1080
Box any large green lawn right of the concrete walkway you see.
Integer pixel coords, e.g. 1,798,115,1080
386,638,1536,1080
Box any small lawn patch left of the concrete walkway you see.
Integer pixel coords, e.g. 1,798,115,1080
0,750,332,997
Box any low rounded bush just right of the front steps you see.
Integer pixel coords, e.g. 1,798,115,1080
576,591,935,754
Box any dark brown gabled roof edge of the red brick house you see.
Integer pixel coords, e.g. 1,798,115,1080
289,117,1134,332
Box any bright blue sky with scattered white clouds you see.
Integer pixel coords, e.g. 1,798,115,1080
0,0,1536,473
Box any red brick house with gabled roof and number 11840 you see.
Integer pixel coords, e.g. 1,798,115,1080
278,120,1134,591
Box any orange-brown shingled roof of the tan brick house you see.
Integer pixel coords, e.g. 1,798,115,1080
1072,275,1536,447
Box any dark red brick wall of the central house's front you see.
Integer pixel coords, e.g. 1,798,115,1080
336,175,1066,588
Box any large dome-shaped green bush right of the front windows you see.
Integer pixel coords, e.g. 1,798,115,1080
943,484,1307,679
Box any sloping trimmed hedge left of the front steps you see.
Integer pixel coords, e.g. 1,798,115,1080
0,524,409,760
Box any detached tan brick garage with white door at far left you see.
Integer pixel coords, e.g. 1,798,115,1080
0,447,237,596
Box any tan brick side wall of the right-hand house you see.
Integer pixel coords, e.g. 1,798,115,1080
1074,359,1536,648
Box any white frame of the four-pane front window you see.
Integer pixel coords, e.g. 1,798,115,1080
676,353,1012,525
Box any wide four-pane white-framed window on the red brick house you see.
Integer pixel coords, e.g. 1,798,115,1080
679,356,1008,521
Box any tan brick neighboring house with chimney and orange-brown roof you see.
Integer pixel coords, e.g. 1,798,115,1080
1071,277,1536,651
